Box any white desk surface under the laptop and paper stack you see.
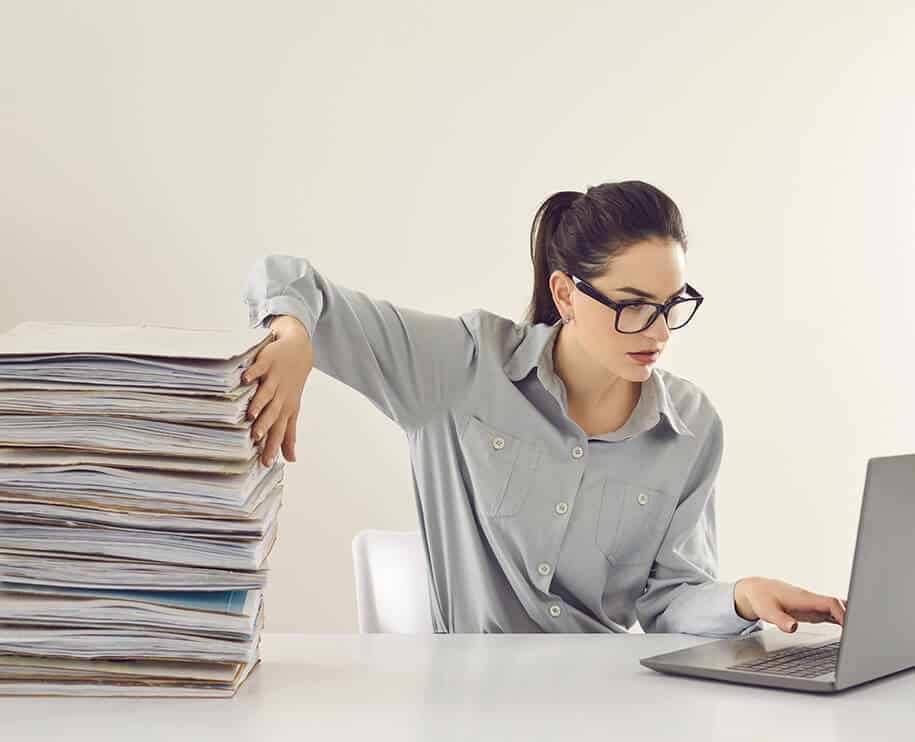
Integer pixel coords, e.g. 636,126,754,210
0,624,915,742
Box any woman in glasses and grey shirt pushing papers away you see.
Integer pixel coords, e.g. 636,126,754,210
245,181,845,637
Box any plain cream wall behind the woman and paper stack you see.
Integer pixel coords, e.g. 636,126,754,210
0,0,915,632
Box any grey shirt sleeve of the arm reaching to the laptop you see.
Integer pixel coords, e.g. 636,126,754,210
636,412,764,638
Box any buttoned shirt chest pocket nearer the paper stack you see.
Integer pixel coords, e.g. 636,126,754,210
461,415,540,517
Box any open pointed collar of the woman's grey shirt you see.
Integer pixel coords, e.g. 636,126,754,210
503,320,695,440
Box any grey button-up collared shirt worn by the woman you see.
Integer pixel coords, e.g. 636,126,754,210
244,255,763,637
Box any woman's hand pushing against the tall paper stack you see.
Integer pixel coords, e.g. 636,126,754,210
242,315,314,466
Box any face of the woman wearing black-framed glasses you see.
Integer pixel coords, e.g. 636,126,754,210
550,239,686,381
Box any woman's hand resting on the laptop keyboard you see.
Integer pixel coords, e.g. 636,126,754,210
734,577,848,634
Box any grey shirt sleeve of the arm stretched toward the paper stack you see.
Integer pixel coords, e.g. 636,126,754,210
244,255,477,431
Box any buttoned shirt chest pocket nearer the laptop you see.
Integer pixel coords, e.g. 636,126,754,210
595,477,673,567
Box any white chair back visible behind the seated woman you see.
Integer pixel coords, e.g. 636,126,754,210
353,529,434,634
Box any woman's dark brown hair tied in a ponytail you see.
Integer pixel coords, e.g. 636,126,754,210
525,180,686,324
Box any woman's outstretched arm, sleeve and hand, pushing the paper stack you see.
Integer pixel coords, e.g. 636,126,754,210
244,255,478,461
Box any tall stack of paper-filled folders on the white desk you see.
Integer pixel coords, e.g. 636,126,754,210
0,322,283,696
